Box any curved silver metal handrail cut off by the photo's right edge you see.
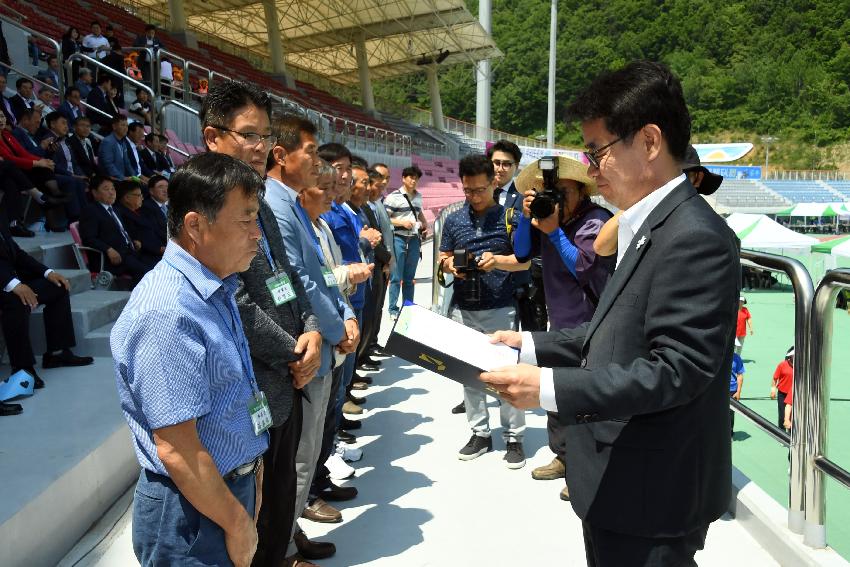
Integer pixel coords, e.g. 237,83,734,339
794,268,850,548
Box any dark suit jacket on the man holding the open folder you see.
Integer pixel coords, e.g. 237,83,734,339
532,181,740,537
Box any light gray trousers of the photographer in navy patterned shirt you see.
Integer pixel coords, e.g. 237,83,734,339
449,306,525,443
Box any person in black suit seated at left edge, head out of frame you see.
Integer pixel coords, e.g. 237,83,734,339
0,223,93,406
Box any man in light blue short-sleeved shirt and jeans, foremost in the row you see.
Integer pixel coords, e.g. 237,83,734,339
110,153,271,567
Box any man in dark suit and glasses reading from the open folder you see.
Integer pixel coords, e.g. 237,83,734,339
482,62,740,567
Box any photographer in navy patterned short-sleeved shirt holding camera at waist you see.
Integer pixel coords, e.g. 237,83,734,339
438,155,528,469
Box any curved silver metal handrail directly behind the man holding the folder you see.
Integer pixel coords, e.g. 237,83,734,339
732,250,815,534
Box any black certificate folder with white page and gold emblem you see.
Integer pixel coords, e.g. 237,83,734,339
385,305,519,394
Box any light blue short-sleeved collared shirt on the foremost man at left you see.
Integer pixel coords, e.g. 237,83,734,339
110,240,268,476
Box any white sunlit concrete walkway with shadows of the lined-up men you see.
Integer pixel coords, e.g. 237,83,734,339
67,242,778,567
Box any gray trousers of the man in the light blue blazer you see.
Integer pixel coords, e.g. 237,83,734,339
286,372,332,556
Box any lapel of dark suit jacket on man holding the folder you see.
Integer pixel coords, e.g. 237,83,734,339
585,180,696,345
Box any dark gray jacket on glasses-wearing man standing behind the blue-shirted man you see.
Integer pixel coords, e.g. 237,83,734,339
236,199,320,426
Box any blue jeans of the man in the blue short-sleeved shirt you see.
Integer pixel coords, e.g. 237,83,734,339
133,470,256,567
